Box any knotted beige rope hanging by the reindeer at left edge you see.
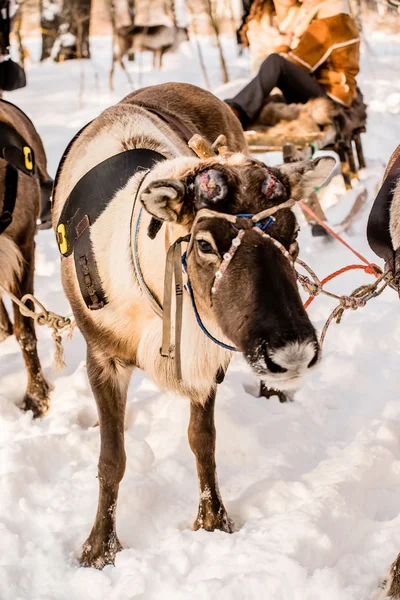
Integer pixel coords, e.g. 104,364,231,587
0,283,76,371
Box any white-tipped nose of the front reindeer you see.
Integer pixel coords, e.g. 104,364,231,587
264,339,319,376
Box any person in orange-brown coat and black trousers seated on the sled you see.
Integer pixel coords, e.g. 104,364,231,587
226,0,360,128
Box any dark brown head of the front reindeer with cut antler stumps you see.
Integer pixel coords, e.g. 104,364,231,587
140,154,335,389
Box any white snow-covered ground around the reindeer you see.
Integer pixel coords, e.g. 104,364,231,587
0,34,400,600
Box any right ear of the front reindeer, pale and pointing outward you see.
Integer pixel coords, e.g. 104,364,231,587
278,156,336,201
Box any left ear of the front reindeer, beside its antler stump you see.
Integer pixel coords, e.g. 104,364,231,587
140,179,185,221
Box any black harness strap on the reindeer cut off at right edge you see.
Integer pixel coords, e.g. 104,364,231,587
367,156,400,262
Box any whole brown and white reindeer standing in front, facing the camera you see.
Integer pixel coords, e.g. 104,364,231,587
53,83,334,568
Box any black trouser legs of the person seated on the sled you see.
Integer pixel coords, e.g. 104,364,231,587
226,54,325,125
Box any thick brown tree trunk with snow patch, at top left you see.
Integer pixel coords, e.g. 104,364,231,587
55,0,92,61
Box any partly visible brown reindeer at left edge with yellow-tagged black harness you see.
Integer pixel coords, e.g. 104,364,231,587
0,100,50,417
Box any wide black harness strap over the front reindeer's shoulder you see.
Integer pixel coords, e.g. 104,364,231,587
56,148,165,310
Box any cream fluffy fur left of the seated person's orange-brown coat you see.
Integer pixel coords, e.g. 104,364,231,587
240,0,300,74
